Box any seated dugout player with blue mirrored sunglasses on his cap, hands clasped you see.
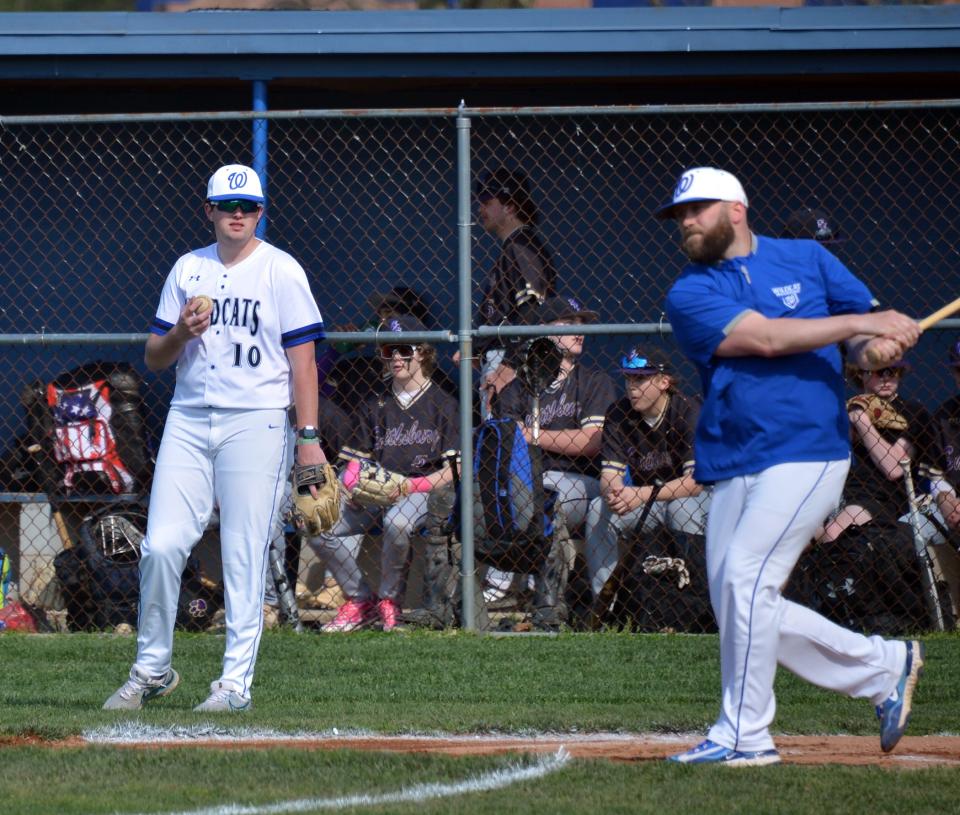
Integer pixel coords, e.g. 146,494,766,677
585,349,708,597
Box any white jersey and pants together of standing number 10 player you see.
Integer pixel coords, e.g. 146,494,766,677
135,234,323,698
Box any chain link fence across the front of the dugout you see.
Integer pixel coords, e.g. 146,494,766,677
0,101,960,632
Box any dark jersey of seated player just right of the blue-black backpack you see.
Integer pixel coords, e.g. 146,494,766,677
494,365,616,476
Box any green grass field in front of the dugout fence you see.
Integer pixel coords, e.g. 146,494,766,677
0,631,960,815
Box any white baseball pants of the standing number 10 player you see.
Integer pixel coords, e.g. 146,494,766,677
135,407,293,696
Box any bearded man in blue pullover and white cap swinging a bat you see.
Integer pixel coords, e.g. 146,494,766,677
658,167,924,766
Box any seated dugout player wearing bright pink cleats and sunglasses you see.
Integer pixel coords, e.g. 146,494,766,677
311,315,459,631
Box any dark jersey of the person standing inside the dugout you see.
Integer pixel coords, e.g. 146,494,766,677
474,225,557,352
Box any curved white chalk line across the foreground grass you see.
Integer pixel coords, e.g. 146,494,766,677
104,748,570,815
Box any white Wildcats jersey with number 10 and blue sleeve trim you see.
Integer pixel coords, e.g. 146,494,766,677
150,243,323,409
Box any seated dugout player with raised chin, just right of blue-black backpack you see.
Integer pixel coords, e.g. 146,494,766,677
495,296,615,531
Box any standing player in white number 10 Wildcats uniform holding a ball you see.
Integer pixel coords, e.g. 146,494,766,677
104,164,325,712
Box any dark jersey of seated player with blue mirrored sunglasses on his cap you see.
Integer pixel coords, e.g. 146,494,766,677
600,393,700,487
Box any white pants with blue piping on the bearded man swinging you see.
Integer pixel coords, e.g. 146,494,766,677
707,459,906,750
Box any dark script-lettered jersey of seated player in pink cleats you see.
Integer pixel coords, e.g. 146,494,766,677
344,383,460,476
